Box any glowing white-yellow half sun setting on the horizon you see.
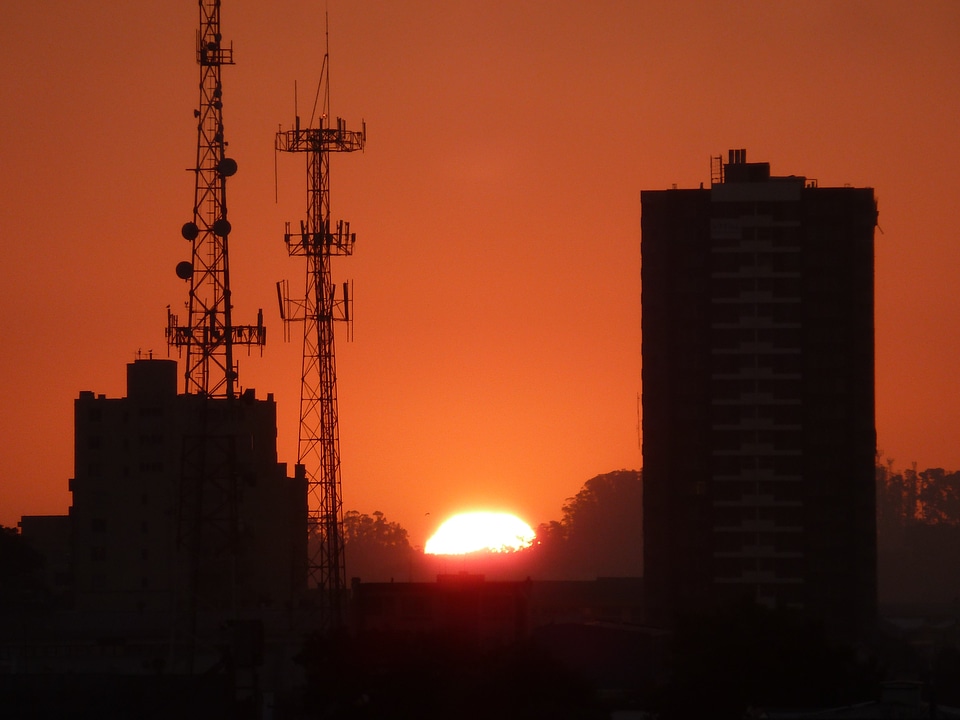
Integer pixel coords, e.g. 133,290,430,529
423,512,535,555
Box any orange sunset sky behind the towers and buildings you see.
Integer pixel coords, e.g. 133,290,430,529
0,0,960,545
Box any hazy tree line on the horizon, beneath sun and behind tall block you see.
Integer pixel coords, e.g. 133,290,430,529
344,458,960,602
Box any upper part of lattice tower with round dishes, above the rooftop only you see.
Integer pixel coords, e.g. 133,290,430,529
166,0,266,398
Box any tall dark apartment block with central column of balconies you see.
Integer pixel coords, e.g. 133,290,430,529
641,150,877,629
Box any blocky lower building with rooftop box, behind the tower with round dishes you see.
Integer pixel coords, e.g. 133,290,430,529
70,359,307,613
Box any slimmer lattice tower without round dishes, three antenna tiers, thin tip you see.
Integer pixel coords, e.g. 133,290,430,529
275,56,366,630
